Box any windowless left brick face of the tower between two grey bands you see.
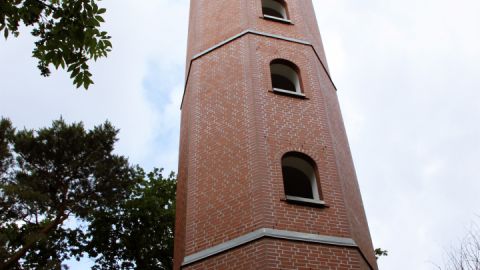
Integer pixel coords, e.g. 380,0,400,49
184,37,255,254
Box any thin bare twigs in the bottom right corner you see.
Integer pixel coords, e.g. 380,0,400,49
437,220,480,270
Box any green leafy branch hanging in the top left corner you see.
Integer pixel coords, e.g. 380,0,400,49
0,0,112,89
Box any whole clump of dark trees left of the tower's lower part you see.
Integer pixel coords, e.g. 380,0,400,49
0,119,175,270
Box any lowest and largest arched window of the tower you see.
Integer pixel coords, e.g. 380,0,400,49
282,152,323,203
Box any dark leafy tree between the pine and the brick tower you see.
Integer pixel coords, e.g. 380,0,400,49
89,169,176,270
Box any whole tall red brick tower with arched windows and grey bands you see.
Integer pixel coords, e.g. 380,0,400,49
174,0,377,270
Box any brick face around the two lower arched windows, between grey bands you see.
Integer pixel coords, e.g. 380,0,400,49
249,36,350,237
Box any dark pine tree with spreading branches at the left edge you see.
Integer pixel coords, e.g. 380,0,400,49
0,119,129,269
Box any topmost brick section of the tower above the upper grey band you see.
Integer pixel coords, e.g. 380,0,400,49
187,0,327,70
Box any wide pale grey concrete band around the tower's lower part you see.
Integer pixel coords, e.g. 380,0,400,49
182,228,357,266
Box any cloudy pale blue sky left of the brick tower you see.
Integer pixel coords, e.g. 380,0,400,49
0,0,189,270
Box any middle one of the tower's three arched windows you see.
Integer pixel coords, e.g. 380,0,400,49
270,59,302,93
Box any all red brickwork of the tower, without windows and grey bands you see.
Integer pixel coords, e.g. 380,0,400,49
175,0,376,269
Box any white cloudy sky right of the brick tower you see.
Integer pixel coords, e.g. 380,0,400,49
314,0,480,270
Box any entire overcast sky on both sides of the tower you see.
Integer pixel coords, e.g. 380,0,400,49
0,0,480,270
